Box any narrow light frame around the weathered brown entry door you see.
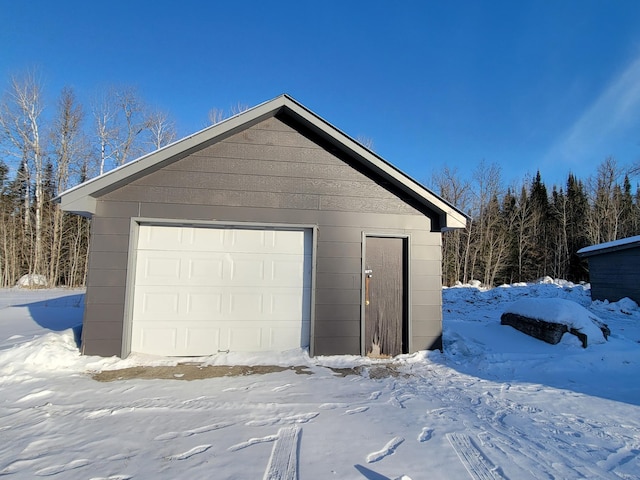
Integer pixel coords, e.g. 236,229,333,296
360,231,412,356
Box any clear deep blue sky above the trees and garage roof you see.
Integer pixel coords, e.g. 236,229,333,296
0,0,640,189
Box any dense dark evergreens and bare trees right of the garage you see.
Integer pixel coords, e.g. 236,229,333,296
431,158,640,286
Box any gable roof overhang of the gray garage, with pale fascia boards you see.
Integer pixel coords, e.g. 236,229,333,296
54,94,469,230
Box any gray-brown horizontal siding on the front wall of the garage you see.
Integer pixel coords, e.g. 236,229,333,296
83,117,442,355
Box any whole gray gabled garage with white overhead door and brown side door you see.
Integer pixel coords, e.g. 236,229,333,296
57,95,467,357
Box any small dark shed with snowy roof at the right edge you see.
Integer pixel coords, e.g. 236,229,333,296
577,235,640,303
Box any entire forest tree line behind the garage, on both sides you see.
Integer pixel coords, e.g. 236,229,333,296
0,73,640,287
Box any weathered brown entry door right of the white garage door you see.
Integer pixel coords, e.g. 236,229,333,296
364,236,408,356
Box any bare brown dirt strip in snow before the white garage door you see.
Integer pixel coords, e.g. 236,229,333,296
92,363,313,382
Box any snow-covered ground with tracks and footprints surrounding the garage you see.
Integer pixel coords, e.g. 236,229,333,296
0,282,640,480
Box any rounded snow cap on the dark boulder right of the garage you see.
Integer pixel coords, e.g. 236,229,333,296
505,298,606,344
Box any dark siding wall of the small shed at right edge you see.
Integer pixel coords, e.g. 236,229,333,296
589,247,640,303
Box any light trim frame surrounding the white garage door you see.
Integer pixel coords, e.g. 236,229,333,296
121,217,318,358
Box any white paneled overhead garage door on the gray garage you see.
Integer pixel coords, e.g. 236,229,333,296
131,225,311,356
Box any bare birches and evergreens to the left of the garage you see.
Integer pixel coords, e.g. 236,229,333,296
0,72,242,287
